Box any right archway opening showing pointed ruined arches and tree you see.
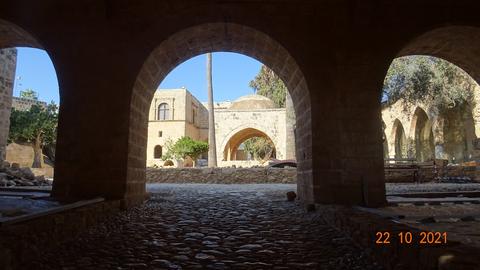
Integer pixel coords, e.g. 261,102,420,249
381,26,480,245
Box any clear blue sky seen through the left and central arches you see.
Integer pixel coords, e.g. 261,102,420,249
13,48,261,104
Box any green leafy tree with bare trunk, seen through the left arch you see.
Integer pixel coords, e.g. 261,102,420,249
8,102,58,168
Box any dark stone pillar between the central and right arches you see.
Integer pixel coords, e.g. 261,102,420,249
306,53,388,207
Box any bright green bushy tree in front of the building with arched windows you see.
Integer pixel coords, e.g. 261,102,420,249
162,136,208,166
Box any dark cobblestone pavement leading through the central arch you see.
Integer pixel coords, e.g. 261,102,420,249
25,184,381,270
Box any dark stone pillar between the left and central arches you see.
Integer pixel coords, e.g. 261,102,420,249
52,43,147,206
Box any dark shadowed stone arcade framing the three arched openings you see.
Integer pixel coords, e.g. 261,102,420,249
0,0,480,206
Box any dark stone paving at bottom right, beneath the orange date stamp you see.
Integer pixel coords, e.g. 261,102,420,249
316,205,480,270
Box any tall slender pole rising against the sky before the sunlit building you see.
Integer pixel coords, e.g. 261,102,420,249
207,53,217,167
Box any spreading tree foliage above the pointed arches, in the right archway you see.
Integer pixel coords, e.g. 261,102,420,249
383,55,476,113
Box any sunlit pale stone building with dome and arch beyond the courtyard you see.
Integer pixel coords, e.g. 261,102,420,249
147,89,288,167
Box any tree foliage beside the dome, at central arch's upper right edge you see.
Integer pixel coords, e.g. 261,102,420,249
249,65,287,108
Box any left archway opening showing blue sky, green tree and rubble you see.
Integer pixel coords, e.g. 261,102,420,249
0,20,60,187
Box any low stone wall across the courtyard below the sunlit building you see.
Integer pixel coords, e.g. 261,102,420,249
147,168,297,184
